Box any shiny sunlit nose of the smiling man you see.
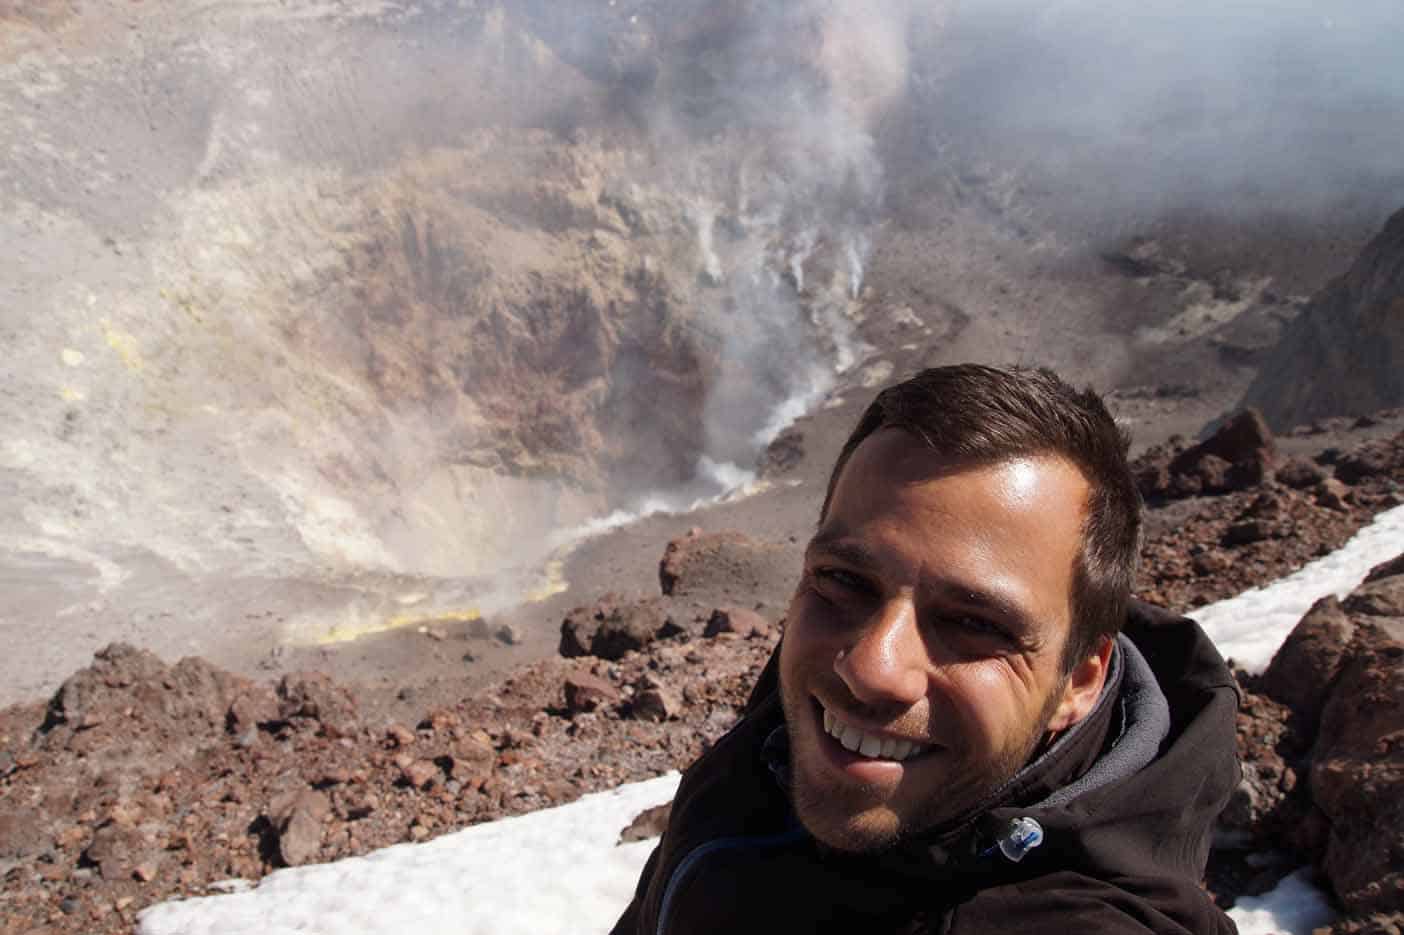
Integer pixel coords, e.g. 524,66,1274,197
834,595,927,705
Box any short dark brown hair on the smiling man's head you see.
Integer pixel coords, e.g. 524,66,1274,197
820,364,1141,674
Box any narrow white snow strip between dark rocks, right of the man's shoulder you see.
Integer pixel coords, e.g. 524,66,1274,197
1189,507,1404,672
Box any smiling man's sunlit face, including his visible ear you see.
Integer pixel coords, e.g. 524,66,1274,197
781,428,1102,851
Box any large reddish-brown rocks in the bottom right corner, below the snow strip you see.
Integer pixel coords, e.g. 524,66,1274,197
1212,555,1404,932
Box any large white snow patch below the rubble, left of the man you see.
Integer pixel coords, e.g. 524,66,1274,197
138,772,678,935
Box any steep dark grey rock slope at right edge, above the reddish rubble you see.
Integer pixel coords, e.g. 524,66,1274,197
1244,211,1404,430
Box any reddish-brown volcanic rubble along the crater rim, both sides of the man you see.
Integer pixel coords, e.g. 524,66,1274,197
0,413,1404,935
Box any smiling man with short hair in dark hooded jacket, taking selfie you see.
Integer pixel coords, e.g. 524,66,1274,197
615,365,1238,935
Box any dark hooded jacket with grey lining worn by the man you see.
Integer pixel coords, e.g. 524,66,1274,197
614,604,1238,935
